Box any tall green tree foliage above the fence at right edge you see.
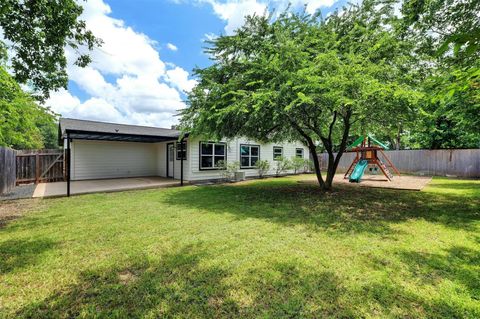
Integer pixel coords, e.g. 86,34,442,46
402,0,480,148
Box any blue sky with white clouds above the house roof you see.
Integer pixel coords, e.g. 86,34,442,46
47,0,345,127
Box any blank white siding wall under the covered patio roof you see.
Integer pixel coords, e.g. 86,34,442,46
71,140,158,180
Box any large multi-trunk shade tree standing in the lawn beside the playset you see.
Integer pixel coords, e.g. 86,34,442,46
182,0,419,190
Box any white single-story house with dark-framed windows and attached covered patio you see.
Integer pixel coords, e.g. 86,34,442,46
59,118,310,192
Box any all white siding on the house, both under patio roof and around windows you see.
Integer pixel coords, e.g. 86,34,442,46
71,138,309,181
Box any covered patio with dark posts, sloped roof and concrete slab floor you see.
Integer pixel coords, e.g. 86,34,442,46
59,118,184,196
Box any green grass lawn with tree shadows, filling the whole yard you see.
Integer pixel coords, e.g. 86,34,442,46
0,177,480,318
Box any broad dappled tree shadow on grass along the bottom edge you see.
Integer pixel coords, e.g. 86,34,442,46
16,246,350,318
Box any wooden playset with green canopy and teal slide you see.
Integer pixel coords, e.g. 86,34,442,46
344,135,400,183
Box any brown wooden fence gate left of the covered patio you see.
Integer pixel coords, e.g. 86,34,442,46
16,150,65,185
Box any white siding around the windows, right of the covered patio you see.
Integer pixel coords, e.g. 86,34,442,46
185,138,309,181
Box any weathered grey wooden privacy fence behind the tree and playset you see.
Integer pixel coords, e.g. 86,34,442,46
318,149,480,178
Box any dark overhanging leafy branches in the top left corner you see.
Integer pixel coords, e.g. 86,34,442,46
0,0,101,99
